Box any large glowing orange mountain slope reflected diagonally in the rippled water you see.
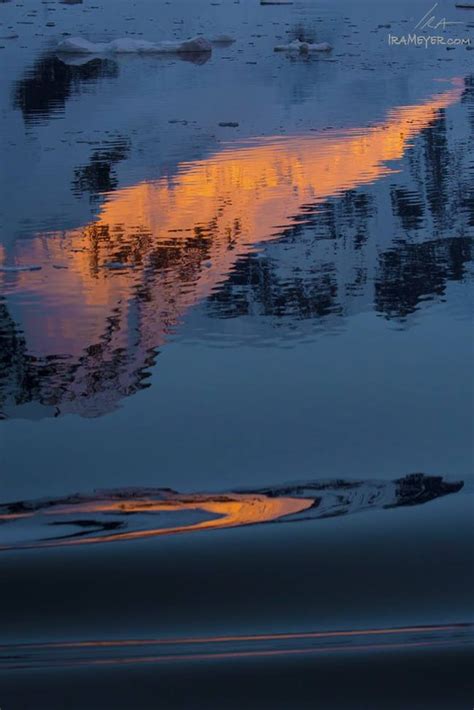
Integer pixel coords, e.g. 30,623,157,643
0,81,462,415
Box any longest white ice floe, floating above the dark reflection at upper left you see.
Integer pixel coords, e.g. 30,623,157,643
56,37,212,54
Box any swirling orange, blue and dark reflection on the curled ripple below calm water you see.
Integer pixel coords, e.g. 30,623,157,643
0,473,463,551
